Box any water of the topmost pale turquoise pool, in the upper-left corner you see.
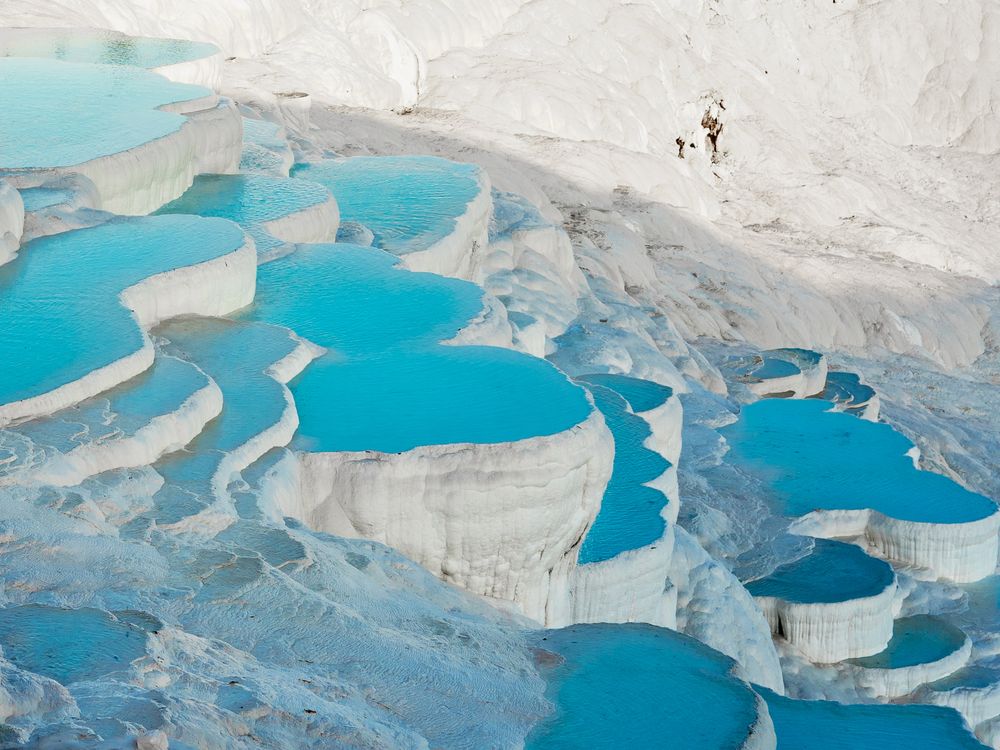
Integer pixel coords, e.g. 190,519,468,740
0,28,219,68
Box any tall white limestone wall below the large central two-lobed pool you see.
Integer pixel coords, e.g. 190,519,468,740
284,410,614,623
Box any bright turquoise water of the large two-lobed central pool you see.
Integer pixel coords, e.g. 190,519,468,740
250,244,590,452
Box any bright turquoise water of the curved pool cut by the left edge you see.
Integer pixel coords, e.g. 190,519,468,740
0,217,243,412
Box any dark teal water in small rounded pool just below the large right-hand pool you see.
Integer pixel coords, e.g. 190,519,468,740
746,539,895,603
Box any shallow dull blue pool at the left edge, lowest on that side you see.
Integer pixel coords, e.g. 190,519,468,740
0,604,146,685
